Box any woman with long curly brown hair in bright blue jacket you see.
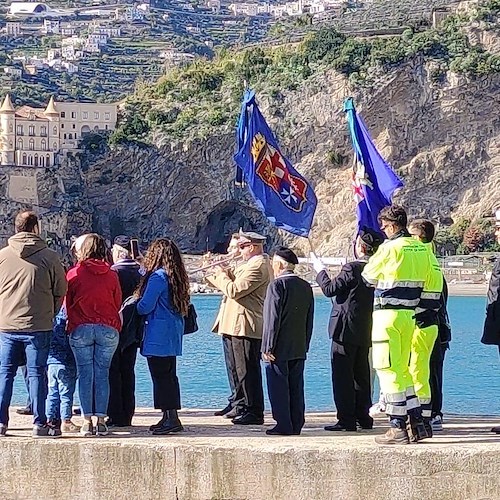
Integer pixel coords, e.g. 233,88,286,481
137,238,189,435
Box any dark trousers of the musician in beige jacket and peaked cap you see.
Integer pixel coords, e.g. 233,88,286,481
231,336,264,417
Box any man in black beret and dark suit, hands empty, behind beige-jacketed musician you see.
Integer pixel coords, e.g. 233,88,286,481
262,247,314,436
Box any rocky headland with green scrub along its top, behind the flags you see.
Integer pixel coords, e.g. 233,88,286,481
2,0,500,254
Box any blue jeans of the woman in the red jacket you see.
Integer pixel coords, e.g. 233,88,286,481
69,325,118,417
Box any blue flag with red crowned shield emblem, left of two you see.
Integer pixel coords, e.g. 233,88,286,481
234,90,318,237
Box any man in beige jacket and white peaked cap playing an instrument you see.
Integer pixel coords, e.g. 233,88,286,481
206,232,271,425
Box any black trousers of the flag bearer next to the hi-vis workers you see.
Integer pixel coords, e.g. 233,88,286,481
332,343,373,428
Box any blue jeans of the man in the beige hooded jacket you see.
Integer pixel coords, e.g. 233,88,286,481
0,332,51,425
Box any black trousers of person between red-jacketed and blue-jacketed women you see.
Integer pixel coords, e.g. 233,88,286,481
108,344,137,426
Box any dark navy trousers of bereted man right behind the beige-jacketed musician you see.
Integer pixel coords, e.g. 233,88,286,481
266,359,305,434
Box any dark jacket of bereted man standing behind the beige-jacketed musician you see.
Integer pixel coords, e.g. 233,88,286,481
262,272,314,361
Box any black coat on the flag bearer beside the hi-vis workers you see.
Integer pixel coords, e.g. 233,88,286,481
316,260,374,346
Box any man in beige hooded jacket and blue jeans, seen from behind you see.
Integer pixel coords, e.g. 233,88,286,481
0,212,67,437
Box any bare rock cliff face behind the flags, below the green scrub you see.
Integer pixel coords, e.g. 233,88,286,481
73,58,500,254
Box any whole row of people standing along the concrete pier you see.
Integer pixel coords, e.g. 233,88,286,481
0,205,500,445
